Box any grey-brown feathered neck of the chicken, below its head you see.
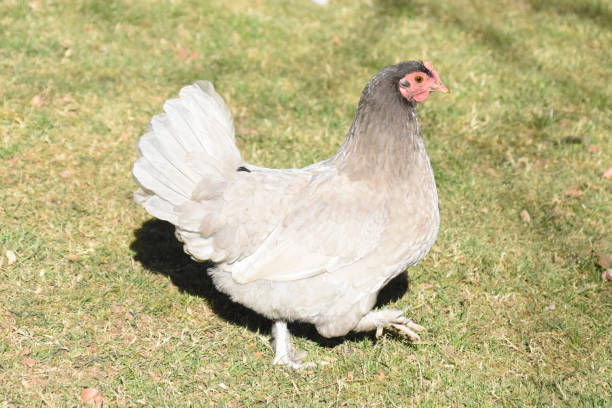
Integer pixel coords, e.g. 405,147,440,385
332,98,433,182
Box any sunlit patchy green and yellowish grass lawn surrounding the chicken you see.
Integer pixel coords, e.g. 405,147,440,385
0,0,612,407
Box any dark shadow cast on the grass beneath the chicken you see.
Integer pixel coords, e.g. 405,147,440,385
130,219,408,347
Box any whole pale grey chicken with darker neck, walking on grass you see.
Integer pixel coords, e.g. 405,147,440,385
132,61,448,368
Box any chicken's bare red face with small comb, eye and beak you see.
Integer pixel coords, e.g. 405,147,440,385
397,61,448,102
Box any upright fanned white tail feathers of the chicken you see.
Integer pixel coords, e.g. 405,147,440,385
132,81,242,224
